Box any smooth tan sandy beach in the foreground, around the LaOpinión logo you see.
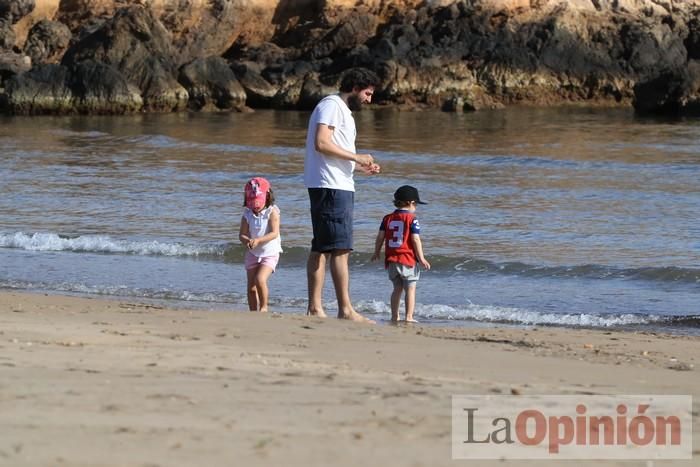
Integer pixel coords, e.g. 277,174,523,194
0,291,700,466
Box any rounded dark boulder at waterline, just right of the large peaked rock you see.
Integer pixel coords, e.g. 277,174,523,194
178,57,246,110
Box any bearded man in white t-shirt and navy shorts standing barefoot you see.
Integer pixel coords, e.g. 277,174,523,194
304,68,380,322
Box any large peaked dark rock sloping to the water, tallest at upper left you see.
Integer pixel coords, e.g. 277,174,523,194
62,6,188,111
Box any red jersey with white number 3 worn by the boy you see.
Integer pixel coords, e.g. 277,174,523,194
379,209,420,267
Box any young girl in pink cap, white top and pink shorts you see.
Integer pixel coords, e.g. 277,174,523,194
238,177,282,312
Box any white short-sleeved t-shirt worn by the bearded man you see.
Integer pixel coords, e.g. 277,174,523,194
304,94,357,191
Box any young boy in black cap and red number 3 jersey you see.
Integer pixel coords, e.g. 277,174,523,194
372,185,430,323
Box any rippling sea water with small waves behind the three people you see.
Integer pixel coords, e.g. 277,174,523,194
0,108,700,334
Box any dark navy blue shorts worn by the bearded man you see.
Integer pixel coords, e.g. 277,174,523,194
309,188,355,253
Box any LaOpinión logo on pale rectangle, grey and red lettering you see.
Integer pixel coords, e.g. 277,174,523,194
452,395,693,460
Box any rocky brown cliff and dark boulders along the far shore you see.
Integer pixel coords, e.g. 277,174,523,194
0,0,700,114
